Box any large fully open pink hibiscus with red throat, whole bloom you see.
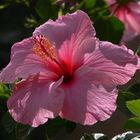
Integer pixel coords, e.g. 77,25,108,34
0,11,138,127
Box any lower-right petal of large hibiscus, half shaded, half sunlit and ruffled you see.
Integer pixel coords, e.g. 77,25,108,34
60,67,117,125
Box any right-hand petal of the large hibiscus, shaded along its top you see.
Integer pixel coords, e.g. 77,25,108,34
85,42,138,90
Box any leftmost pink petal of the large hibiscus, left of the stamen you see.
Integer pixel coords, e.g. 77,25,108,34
0,38,47,83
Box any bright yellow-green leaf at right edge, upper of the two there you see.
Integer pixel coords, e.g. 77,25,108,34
126,99,140,117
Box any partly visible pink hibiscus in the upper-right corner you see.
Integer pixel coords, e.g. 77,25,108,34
107,0,140,41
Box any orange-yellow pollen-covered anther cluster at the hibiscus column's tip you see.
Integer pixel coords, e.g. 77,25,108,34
33,35,57,60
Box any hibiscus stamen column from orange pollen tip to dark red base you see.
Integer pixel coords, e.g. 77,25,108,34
33,35,73,83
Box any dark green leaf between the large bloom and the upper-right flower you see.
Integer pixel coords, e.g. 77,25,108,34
94,15,124,44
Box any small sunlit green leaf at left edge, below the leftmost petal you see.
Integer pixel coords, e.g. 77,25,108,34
0,83,11,99
